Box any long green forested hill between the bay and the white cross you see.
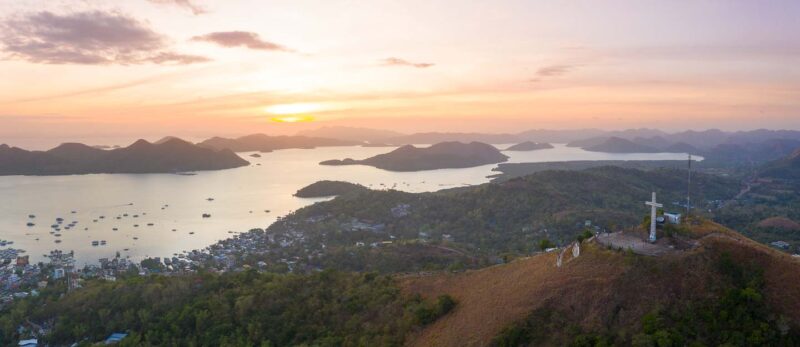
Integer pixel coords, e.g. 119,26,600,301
260,167,740,271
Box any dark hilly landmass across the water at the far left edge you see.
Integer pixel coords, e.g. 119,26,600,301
0,138,249,175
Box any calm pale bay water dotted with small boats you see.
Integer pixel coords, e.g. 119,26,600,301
0,145,686,265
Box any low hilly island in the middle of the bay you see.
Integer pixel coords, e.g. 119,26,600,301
320,142,508,172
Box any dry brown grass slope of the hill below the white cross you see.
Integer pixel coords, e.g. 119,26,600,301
401,222,800,346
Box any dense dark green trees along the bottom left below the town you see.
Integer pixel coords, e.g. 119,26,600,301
0,270,456,346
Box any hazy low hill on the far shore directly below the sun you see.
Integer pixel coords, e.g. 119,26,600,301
197,134,361,152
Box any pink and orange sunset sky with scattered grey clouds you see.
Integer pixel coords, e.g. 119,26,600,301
0,0,800,148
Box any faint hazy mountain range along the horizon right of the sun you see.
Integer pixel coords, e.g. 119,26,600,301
304,127,800,165
